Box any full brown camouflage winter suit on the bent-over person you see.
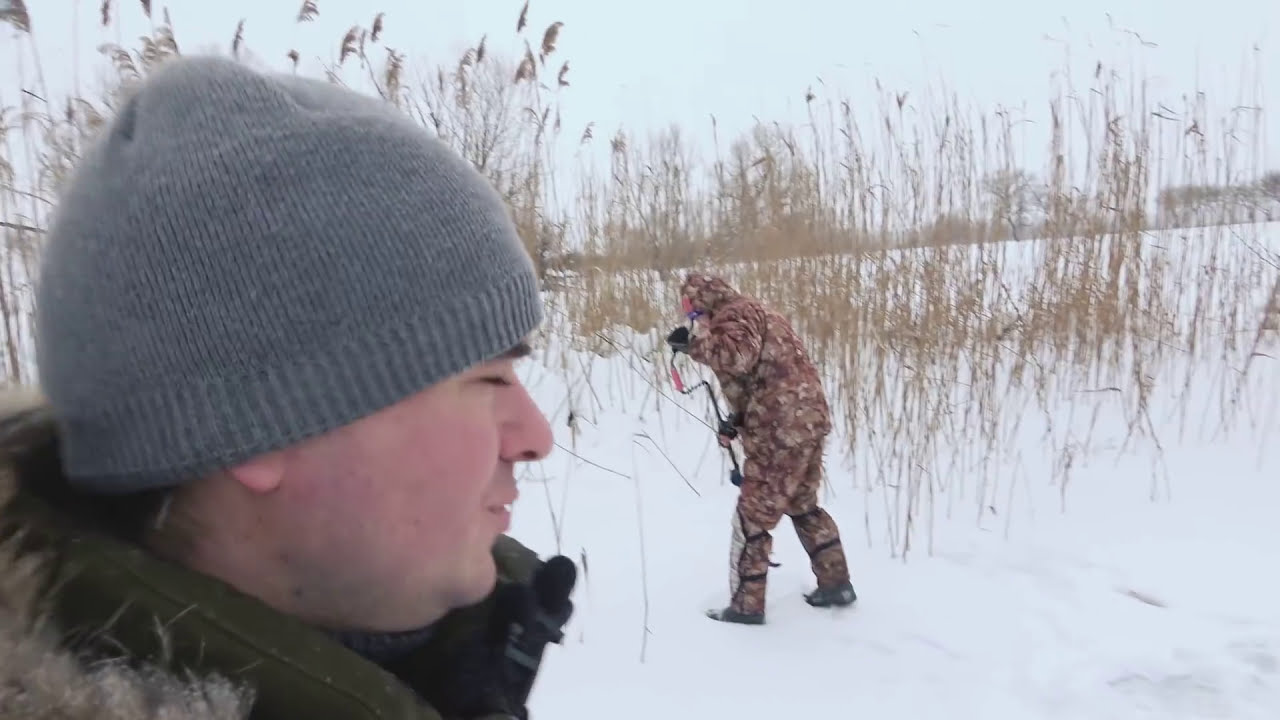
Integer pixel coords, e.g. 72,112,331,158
681,274,849,615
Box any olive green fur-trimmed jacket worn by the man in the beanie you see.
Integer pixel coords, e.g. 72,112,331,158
0,386,565,720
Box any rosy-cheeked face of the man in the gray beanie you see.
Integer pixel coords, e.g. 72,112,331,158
234,340,553,630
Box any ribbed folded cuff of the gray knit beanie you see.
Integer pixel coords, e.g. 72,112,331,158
63,273,543,492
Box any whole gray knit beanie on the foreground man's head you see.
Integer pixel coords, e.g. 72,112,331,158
36,58,541,493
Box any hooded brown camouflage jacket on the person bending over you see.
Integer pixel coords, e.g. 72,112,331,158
680,274,831,454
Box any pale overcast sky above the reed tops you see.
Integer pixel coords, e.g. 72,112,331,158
0,0,1280,193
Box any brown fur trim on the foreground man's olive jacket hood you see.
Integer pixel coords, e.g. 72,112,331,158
0,391,250,720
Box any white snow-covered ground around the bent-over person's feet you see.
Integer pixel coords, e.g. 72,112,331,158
512,225,1280,720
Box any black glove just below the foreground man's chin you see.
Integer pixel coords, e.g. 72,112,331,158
393,556,577,720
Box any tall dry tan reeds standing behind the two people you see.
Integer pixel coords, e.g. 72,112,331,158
0,0,1280,552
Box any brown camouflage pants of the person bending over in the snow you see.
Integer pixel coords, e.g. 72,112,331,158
730,441,849,612
